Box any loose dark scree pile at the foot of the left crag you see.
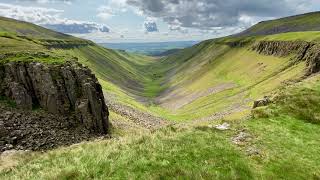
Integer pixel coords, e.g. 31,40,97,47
0,104,105,153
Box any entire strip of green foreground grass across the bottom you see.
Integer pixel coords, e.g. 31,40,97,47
0,112,320,179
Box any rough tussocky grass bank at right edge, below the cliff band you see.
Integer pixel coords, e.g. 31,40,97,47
254,76,320,124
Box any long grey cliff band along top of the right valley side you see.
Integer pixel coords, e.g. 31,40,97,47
252,41,320,75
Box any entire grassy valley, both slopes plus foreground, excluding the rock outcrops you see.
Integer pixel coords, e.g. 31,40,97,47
0,15,320,179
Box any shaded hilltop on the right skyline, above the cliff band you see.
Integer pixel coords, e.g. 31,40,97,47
235,12,320,36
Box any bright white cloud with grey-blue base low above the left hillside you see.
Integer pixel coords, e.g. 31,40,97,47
0,3,110,34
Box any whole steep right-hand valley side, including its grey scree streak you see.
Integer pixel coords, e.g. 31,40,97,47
146,33,317,120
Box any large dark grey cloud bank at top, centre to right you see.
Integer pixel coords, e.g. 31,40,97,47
127,0,316,30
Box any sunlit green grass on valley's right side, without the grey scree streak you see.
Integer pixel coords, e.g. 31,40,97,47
149,33,306,120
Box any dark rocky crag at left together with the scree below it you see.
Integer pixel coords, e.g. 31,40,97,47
0,60,109,151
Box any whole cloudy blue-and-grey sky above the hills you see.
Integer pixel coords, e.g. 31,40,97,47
0,0,320,42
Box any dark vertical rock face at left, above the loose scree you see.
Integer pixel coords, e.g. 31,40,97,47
0,61,109,134
